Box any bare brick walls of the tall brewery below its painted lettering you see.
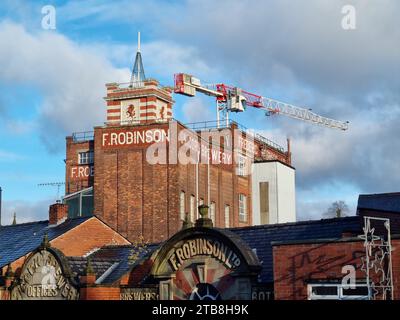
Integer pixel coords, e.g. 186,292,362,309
94,124,252,242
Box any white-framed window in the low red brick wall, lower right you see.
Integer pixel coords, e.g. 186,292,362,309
308,283,369,300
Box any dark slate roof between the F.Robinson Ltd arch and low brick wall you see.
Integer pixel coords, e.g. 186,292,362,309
230,216,362,283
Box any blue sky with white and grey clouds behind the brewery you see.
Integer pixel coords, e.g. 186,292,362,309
0,0,400,224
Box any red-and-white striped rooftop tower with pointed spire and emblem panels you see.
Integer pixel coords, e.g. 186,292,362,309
104,32,173,126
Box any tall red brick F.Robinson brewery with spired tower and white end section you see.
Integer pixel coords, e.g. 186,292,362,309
64,40,296,242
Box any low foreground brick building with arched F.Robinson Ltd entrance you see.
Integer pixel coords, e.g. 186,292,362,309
0,192,400,300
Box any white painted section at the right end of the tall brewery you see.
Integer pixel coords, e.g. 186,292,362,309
252,161,296,225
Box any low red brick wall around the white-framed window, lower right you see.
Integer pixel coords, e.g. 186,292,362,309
273,240,400,300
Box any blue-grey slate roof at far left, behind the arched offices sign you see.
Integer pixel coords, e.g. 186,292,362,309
0,217,92,268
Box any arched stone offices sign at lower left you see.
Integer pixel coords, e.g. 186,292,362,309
11,249,78,300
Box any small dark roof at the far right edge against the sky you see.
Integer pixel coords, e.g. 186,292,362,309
357,192,400,213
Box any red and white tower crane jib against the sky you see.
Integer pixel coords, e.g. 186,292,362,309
174,73,349,130
